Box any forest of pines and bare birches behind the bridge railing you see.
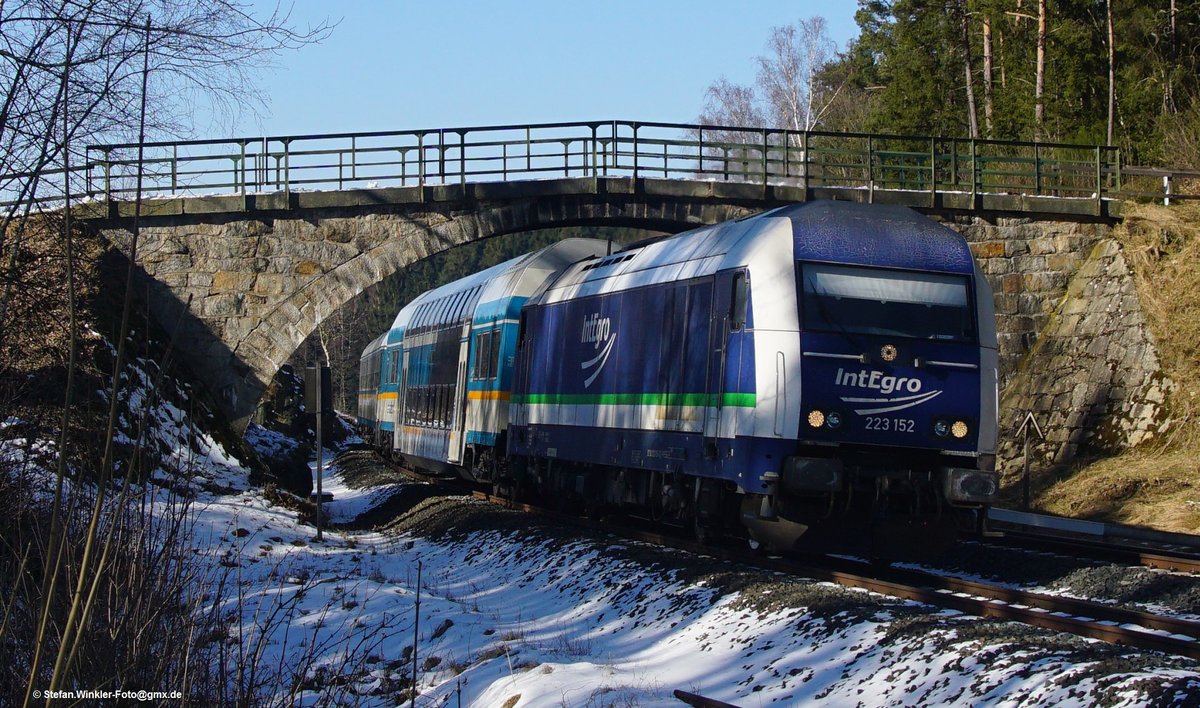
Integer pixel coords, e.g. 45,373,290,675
700,0,1200,169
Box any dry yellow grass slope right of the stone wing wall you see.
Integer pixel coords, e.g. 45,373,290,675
1037,204,1200,533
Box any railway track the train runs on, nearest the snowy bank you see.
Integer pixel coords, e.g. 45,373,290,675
474,492,1200,660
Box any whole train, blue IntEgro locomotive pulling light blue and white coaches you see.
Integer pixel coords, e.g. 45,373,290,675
358,200,998,558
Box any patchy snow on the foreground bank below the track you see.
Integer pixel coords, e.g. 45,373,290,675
0,352,1200,708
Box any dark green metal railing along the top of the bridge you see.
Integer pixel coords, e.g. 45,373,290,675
0,120,1200,212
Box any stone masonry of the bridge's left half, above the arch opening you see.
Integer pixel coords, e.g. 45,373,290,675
92,180,758,430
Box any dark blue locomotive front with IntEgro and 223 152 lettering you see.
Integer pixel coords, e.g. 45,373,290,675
743,204,997,557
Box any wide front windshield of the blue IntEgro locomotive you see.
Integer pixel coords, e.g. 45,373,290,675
800,263,976,342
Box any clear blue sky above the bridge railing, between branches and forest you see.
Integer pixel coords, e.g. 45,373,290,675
225,0,857,137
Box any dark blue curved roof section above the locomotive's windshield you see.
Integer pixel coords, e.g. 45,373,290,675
763,200,974,274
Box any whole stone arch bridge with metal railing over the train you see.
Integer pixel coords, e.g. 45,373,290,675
77,122,1150,477
